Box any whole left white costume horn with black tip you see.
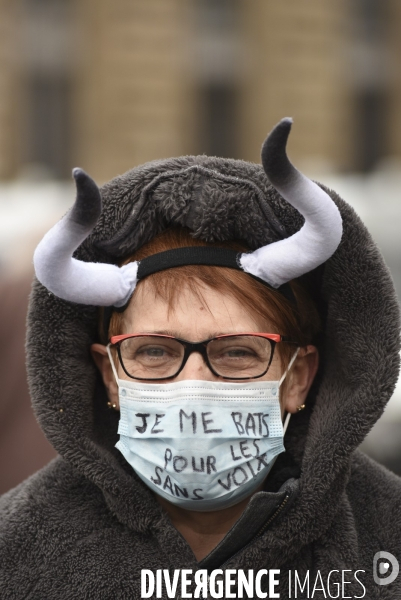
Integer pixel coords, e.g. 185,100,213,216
33,169,138,307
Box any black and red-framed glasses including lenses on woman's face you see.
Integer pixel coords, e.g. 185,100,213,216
110,333,295,381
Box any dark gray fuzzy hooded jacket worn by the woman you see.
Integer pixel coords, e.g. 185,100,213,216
0,151,401,600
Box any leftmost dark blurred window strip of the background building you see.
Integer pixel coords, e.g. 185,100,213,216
21,0,74,177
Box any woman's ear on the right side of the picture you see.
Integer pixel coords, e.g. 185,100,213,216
283,345,319,413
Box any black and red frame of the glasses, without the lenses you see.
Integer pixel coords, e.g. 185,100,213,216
109,332,297,381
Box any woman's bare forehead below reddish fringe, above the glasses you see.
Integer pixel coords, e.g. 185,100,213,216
122,280,269,341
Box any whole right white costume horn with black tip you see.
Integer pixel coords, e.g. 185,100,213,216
240,118,342,288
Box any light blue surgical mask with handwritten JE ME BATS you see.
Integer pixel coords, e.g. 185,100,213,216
109,351,298,511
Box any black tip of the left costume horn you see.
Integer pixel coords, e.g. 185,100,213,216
71,167,102,227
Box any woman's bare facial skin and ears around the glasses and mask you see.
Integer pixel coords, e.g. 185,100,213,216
92,280,318,412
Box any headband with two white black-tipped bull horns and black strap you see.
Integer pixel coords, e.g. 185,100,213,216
33,118,342,308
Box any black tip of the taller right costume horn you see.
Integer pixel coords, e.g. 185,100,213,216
262,117,292,185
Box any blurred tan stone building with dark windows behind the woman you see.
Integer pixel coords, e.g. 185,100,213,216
0,0,401,181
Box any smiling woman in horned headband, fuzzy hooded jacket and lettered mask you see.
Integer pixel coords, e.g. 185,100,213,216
1,120,401,599
